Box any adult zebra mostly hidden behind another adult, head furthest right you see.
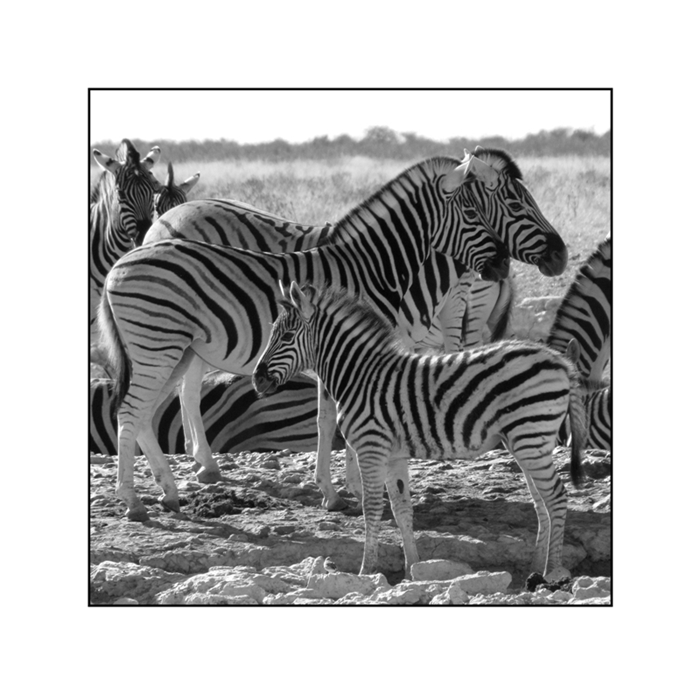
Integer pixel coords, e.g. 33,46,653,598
144,148,567,508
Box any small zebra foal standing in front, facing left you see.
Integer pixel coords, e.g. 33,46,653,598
253,282,585,577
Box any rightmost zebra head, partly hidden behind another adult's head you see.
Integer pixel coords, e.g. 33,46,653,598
464,146,568,277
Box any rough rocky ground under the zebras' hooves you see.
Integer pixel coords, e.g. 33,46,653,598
90,448,612,605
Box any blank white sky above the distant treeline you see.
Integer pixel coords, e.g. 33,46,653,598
90,90,610,144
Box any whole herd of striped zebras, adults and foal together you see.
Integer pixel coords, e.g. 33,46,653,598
90,140,611,584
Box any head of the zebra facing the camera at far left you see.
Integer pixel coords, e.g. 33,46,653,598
92,140,160,245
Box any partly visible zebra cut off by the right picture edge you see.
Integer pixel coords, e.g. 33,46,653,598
547,237,612,451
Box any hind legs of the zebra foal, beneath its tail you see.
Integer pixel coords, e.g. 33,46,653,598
509,444,570,580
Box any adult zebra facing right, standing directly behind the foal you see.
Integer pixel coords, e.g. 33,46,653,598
100,152,509,520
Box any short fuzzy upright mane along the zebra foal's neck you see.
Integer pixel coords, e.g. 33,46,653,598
296,284,408,353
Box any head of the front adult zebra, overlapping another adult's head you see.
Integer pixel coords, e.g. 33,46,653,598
433,155,510,282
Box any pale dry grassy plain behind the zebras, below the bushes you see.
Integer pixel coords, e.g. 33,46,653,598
91,152,611,301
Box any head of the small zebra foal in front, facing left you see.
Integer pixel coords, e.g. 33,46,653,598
253,282,315,395
